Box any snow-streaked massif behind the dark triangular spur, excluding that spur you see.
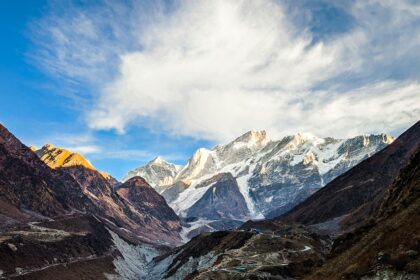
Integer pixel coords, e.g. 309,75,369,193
126,131,393,218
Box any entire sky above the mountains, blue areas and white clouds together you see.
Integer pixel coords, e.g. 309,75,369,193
0,0,420,178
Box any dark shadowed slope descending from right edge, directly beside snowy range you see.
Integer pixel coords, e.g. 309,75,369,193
280,122,420,228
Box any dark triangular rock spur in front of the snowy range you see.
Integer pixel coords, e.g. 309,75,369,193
186,173,249,220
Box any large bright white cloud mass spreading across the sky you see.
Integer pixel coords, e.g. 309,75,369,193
32,0,420,141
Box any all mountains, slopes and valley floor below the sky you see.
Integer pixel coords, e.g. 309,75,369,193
0,122,420,280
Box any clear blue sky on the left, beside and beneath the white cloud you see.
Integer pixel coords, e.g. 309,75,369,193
0,1,214,178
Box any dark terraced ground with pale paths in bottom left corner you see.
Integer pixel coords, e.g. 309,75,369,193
0,215,120,279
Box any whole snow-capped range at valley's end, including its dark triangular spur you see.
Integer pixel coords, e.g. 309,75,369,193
124,131,394,225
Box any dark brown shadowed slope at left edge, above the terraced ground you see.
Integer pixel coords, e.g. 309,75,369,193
0,125,89,221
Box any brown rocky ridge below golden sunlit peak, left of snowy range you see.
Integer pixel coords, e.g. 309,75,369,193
55,166,181,245
